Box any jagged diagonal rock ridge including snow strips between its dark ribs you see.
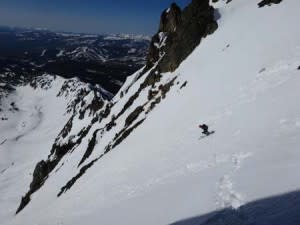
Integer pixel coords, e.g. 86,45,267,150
17,0,217,213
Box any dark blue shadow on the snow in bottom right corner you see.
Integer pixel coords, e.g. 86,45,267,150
171,191,300,225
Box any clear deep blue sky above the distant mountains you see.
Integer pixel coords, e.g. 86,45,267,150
0,0,190,34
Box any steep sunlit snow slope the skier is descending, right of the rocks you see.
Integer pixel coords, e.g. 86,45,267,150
0,0,300,225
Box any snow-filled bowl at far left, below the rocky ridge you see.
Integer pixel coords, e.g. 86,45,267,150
0,75,102,224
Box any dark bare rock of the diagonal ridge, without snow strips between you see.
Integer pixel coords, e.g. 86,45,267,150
17,0,218,213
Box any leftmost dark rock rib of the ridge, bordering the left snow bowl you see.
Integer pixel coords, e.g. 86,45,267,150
16,89,110,213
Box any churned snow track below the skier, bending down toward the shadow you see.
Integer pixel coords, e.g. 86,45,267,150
109,152,252,206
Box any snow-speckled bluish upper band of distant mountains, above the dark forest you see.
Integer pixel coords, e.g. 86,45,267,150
0,27,149,65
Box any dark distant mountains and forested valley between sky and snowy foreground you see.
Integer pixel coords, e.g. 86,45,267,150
0,27,150,93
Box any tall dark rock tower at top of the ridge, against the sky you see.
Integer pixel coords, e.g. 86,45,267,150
145,0,218,72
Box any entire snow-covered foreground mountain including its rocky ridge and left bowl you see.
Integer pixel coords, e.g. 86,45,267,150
0,0,300,225
